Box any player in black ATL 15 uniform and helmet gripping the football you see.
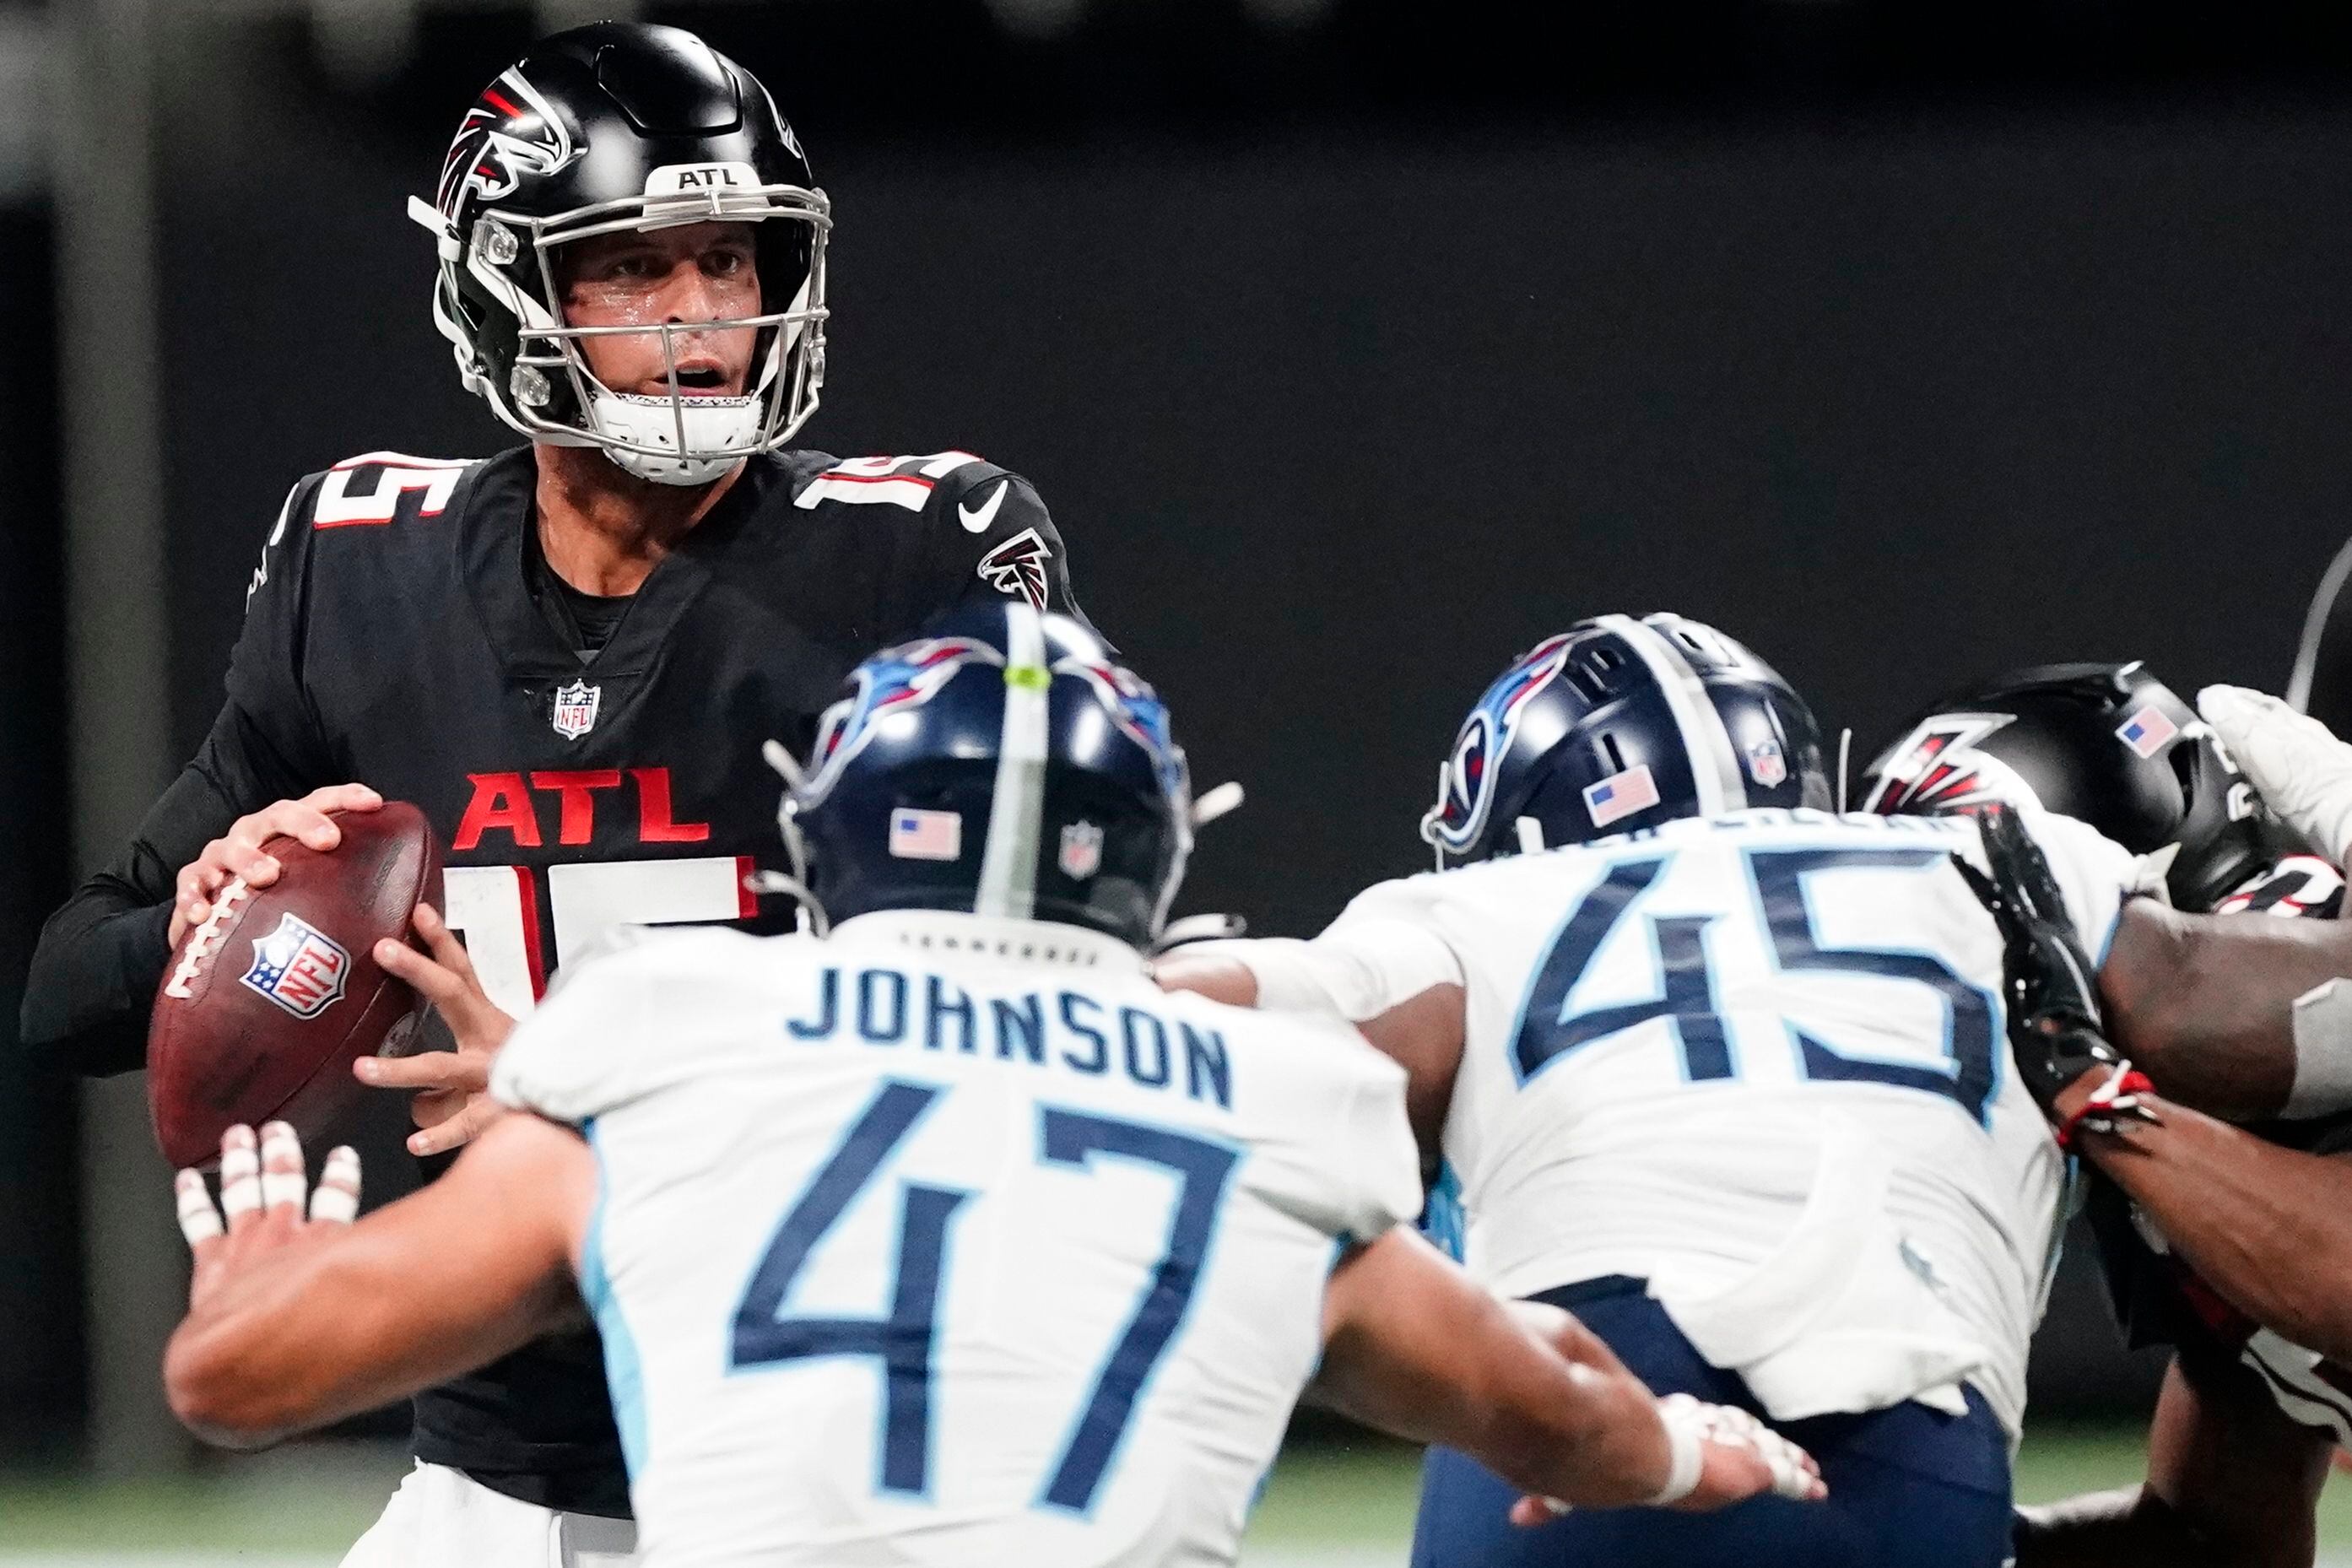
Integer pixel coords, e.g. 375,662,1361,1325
24,24,1075,1568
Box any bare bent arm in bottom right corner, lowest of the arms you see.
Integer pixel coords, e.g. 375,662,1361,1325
2015,1349,2331,1568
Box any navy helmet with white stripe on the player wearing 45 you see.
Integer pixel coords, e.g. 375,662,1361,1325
1420,616,1832,870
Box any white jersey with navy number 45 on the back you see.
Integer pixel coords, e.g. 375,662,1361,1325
1279,811,2138,1434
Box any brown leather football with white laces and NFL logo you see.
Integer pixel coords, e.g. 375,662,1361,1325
149,799,442,1168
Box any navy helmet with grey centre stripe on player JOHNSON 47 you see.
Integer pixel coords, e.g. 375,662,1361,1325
778,599,1192,948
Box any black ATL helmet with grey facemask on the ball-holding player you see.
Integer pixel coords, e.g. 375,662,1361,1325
409,21,833,484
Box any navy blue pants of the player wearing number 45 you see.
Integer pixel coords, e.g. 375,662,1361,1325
1414,1277,2011,1568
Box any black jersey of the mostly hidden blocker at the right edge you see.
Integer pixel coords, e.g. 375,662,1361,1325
2084,856,2352,1443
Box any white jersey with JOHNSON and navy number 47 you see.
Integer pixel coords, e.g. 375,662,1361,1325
494,915,1420,1568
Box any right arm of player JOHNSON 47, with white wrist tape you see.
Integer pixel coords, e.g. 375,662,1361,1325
1310,1227,1820,1523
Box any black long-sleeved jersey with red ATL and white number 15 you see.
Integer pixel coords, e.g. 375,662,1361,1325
26,446,1077,1514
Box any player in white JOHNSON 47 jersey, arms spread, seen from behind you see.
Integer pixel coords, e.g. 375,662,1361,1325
167,604,1820,1568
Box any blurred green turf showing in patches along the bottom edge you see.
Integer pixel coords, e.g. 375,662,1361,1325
0,1425,2352,1568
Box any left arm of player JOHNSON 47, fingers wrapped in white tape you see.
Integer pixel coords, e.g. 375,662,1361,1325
165,1114,597,1448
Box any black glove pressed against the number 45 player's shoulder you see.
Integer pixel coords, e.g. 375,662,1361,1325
1952,806,2131,1126
